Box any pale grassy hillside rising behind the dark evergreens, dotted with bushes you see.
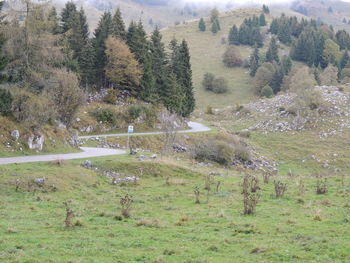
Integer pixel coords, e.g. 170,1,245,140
162,9,268,109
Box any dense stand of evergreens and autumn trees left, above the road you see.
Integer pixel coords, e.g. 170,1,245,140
0,1,195,132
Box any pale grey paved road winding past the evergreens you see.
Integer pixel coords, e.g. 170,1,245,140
0,121,210,165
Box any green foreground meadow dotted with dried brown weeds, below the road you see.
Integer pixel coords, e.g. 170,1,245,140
0,157,350,263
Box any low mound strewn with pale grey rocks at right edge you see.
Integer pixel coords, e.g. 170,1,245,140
231,86,350,138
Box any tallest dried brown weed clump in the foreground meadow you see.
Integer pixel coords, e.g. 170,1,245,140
242,175,260,215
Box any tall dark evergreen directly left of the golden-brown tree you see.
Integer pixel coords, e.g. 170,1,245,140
92,12,112,86
